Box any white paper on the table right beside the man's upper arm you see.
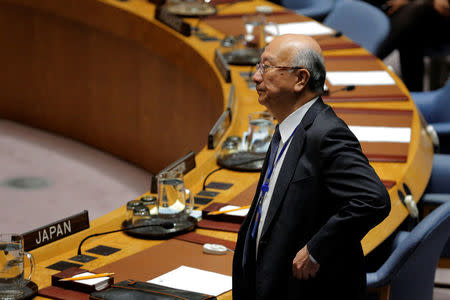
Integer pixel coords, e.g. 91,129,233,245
348,126,411,143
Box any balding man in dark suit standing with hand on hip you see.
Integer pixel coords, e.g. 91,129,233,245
233,35,390,300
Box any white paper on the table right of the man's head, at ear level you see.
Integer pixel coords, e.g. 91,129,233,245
327,71,395,85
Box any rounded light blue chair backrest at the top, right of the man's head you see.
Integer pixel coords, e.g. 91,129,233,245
324,0,390,55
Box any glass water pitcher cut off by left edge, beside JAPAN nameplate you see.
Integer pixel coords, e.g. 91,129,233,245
0,233,35,299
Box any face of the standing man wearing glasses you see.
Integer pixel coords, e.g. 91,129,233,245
252,40,297,111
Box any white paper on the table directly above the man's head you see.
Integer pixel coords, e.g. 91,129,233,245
265,21,335,35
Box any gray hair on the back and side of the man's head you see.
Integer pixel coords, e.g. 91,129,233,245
292,49,326,93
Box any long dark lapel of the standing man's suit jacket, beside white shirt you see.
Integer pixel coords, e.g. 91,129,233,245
261,97,328,238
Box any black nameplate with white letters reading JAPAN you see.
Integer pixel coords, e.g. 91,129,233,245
23,210,89,251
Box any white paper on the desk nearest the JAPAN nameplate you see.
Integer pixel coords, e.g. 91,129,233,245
147,266,232,297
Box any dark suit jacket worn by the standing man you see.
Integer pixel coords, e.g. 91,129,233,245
233,98,390,300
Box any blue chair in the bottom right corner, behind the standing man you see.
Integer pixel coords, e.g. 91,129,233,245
367,202,450,300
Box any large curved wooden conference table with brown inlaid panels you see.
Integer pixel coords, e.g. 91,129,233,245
0,0,433,299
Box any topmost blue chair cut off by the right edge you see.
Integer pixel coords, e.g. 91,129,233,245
411,80,450,154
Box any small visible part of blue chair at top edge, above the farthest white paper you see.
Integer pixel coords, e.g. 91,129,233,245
280,0,335,20
